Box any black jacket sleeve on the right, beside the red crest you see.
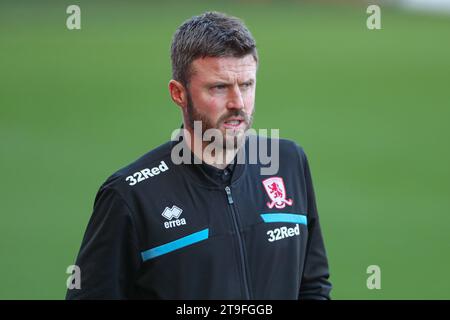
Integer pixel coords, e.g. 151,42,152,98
299,149,332,300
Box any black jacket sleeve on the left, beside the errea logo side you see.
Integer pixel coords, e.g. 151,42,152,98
66,187,140,300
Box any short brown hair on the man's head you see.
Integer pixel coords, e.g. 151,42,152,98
171,12,258,86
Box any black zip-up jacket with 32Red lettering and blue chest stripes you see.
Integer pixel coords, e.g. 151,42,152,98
66,136,331,299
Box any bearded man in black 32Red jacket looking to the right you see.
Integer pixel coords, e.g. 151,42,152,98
67,12,331,299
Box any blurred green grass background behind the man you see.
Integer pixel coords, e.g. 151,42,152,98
0,1,450,299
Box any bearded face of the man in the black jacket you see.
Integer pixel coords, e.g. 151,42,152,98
186,55,257,148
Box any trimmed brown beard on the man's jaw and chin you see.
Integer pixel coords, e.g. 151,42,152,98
186,90,254,149
